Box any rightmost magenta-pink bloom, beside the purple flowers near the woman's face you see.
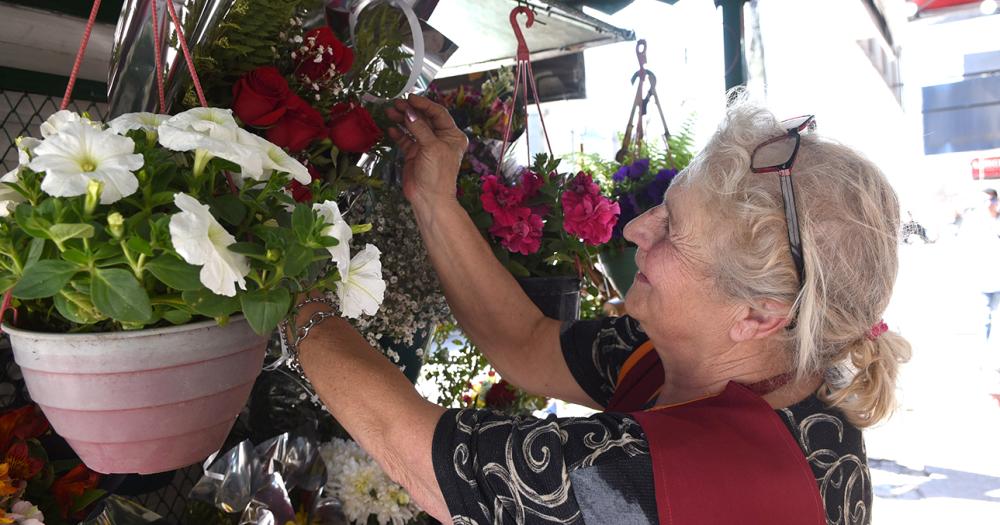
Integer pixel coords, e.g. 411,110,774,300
561,173,621,246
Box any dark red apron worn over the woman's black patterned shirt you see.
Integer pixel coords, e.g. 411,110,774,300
608,343,826,525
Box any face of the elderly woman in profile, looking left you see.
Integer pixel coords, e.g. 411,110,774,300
625,187,735,344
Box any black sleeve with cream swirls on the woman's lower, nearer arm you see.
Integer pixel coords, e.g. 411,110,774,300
435,409,649,525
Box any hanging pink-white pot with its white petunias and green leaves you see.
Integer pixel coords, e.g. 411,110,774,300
0,107,385,473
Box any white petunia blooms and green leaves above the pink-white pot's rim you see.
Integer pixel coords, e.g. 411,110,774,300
0,108,385,334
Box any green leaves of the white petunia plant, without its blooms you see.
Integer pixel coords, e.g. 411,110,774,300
0,119,364,335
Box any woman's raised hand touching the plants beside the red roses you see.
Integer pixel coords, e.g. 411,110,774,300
385,95,469,206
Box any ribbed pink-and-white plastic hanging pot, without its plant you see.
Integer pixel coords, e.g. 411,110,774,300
3,317,267,474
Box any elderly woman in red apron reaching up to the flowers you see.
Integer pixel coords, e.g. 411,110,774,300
299,96,909,524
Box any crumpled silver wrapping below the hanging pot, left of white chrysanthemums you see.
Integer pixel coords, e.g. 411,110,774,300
185,433,347,525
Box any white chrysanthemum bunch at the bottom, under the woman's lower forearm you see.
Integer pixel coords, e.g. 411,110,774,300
320,438,420,525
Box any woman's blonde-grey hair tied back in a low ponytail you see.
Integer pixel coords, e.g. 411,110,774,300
675,93,910,427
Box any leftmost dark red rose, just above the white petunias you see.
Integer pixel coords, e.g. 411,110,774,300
233,66,292,126
